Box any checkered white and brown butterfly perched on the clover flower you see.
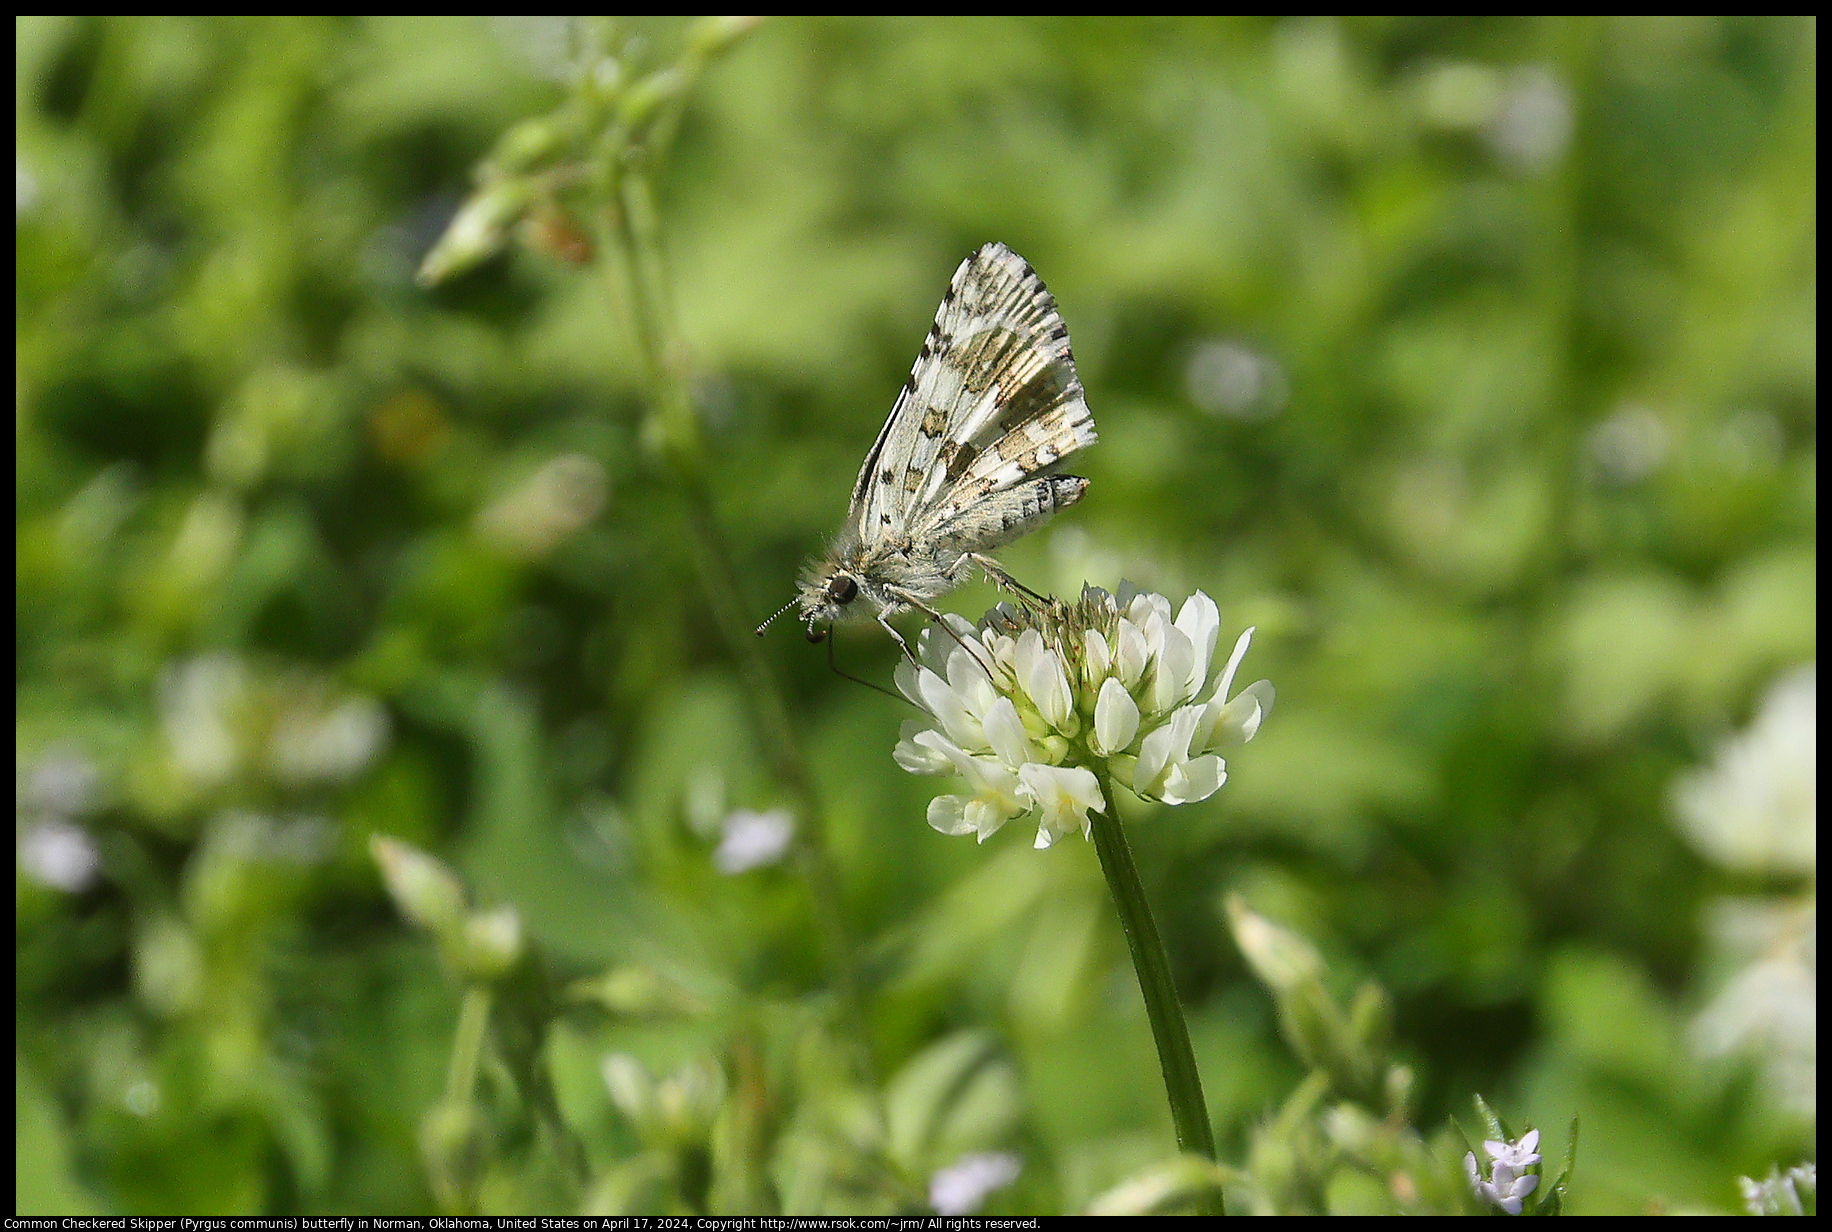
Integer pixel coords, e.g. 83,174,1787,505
758,244,1097,655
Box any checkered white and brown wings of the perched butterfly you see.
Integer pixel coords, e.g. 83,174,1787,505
852,244,1096,543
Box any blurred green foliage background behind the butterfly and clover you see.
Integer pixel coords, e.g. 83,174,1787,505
15,17,1817,1214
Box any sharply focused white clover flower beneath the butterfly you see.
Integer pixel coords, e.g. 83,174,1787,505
894,583,1273,847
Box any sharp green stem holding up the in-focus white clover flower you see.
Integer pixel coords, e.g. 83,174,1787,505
1090,770,1226,1216
